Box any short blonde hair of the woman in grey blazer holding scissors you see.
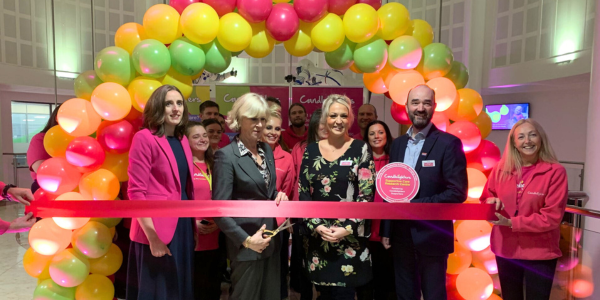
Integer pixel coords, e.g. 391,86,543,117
225,93,271,132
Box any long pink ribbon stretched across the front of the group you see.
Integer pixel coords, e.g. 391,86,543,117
30,200,497,220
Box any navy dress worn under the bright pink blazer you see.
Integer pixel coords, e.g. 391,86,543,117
127,137,195,300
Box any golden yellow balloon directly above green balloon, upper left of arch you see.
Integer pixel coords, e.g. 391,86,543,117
142,4,181,44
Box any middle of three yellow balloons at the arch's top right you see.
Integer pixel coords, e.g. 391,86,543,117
343,3,379,43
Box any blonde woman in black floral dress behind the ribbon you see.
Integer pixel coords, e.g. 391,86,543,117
298,95,375,300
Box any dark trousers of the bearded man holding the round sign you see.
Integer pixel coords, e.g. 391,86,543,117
390,227,448,300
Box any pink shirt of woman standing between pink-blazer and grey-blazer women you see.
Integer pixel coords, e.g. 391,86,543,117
192,163,220,251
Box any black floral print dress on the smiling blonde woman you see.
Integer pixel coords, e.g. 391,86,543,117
298,140,375,287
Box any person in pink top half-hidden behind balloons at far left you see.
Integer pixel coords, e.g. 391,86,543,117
27,105,60,193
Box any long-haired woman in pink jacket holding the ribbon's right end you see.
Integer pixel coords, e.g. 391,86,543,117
480,119,568,300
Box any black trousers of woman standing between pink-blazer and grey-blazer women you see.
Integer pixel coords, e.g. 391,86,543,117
194,249,221,300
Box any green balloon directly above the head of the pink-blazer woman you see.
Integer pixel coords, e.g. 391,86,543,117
131,39,171,78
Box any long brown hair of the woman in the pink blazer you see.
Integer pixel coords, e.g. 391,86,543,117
142,84,189,139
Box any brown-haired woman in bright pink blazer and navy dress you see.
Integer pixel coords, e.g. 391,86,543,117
127,85,195,300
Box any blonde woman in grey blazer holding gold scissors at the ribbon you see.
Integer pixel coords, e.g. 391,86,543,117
212,93,288,300
